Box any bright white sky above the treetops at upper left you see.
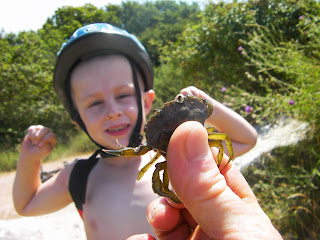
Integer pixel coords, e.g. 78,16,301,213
0,0,205,33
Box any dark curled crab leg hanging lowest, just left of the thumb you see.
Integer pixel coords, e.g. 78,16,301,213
152,162,181,203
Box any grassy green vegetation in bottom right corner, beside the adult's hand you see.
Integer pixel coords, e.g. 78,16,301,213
243,127,320,239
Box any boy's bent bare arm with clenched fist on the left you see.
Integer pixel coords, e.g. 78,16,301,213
13,126,72,216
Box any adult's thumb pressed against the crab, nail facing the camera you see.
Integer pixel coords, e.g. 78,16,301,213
167,122,248,239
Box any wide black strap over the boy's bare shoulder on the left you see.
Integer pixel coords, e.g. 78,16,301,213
69,150,101,211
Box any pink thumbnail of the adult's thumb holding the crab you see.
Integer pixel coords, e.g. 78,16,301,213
186,126,209,162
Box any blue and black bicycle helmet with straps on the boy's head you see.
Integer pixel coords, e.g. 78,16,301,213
53,23,154,147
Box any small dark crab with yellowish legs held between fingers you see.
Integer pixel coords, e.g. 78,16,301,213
103,96,233,203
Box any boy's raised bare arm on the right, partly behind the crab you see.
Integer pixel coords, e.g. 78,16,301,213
180,86,258,157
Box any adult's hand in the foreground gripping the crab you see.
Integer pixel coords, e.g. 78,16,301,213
129,122,282,240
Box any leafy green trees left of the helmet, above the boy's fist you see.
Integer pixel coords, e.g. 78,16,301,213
0,31,75,148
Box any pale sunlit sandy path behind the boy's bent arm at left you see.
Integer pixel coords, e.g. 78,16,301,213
0,157,86,240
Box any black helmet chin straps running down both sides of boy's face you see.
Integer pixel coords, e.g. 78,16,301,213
73,57,142,159
